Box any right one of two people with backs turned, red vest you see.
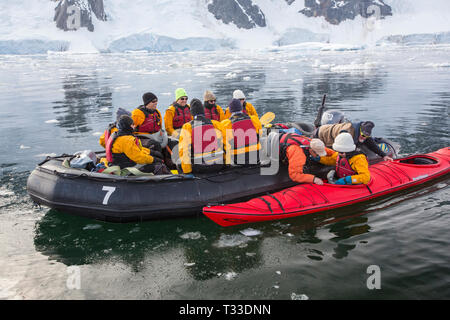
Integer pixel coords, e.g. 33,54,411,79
221,99,262,165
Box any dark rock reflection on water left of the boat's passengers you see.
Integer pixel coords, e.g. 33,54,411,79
53,74,112,134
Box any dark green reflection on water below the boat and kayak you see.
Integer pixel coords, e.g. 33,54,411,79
34,202,378,280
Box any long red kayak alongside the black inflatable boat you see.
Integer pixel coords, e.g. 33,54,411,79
203,148,450,227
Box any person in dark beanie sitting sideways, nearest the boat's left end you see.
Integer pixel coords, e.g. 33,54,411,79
106,115,169,174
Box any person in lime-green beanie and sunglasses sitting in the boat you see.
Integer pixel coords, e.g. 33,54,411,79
164,88,192,138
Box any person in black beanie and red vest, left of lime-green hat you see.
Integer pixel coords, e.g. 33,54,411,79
131,92,166,152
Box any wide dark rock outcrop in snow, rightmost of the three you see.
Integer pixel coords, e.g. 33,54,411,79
298,0,392,24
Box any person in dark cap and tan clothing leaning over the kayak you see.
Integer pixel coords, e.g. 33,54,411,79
313,121,392,161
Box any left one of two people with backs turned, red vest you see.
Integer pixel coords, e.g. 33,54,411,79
178,99,229,173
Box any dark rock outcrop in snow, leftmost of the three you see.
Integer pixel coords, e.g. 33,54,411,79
53,0,106,32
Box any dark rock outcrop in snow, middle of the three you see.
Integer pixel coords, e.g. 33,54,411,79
208,0,266,29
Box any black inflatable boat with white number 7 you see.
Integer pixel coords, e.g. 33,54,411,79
27,156,294,222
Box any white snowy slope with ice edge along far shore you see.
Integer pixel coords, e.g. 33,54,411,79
0,0,450,53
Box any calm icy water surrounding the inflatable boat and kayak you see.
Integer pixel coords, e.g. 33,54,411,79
0,47,450,299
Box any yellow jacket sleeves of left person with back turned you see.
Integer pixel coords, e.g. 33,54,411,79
178,120,231,173
